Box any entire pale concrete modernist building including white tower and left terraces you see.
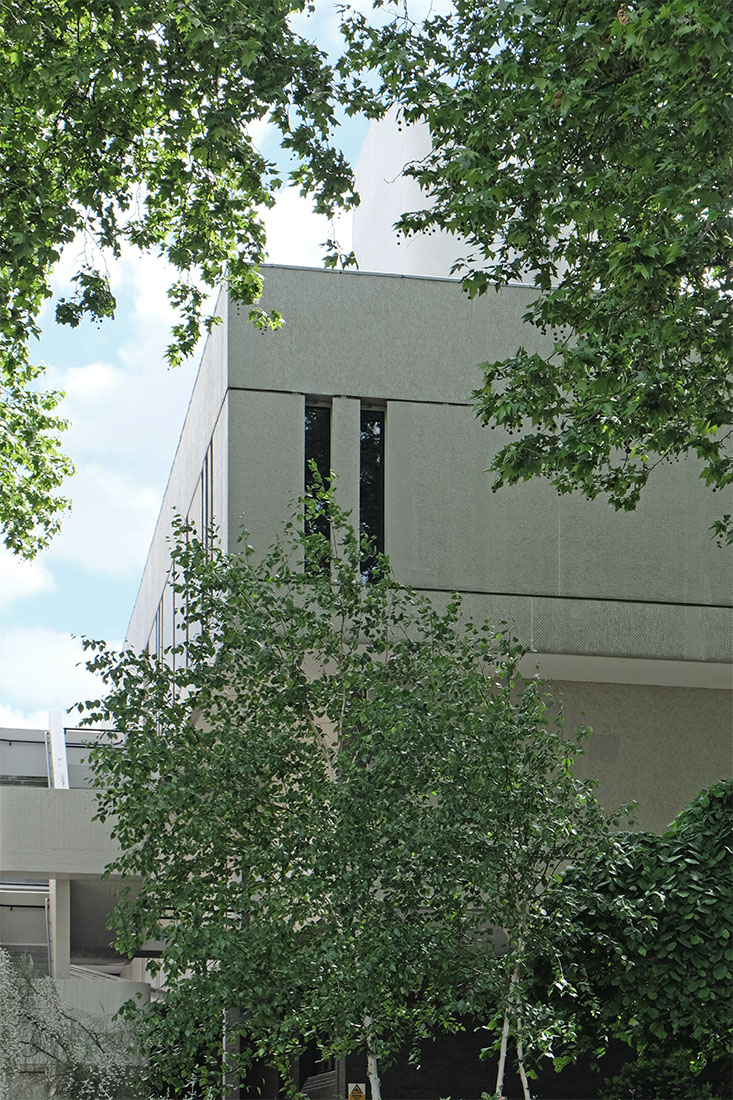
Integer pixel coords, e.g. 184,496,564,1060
0,116,733,1097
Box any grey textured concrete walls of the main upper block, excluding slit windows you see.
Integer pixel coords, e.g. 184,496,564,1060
128,267,733,829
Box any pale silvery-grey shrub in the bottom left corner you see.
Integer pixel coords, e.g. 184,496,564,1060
0,948,143,1100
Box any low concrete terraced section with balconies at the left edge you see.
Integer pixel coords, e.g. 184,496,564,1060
0,714,151,1073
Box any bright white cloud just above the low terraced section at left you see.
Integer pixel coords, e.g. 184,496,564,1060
0,627,108,712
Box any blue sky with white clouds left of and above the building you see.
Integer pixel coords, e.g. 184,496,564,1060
0,7,367,727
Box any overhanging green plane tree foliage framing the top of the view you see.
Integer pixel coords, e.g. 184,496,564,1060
7,0,733,556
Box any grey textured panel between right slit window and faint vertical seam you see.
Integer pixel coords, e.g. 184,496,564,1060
386,403,558,593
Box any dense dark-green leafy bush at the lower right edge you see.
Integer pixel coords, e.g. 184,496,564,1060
550,780,733,1071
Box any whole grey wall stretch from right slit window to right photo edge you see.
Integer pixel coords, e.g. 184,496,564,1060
387,403,733,603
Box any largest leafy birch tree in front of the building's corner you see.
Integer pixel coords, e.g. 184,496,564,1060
81,494,608,1098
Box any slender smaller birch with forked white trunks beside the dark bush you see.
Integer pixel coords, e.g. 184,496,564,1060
468,730,639,1100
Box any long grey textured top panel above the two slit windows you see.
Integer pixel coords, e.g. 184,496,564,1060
229,267,548,402
